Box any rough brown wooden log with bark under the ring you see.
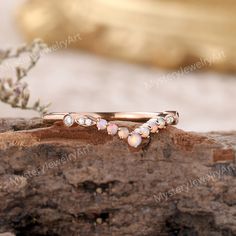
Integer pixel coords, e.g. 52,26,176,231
0,119,236,236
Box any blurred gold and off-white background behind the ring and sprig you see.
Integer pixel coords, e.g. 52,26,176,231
0,0,236,132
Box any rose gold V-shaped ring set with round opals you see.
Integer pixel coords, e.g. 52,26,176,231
43,111,179,147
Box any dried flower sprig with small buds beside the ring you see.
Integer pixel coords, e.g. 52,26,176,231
0,40,50,114
